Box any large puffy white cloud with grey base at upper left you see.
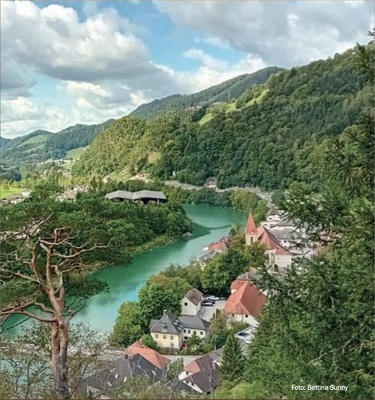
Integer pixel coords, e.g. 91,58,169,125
1,1,181,88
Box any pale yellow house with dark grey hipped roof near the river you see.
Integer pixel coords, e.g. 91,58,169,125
150,311,184,350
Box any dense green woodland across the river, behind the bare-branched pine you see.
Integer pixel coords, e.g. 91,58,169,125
0,183,191,307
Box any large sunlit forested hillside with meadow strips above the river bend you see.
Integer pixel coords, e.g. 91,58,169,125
74,46,373,189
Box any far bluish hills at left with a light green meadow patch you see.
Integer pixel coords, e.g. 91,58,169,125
0,120,113,165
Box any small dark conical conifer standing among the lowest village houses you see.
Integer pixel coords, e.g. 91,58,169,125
221,333,245,381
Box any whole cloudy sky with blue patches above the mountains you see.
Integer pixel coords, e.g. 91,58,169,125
0,0,375,138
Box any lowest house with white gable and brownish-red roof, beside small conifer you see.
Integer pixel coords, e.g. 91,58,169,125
178,352,221,394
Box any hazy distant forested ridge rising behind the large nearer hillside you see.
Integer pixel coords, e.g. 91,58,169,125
130,67,281,118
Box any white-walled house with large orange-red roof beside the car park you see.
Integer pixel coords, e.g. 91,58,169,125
224,280,267,326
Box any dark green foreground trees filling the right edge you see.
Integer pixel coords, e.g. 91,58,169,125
216,36,375,399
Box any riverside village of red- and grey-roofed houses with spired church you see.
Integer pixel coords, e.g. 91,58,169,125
82,208,314,399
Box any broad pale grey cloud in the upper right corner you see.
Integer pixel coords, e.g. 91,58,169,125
155,1,374,67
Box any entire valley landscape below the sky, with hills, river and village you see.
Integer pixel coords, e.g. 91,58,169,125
0,33,375,400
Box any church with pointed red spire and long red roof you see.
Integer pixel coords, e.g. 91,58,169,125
245,214,292,272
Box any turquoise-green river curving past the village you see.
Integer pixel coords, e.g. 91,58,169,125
4,205,247,335
